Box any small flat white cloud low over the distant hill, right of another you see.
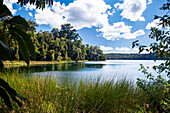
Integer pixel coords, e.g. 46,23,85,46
115,47,139,53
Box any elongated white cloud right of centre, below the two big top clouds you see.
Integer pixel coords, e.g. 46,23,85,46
97,22,145,40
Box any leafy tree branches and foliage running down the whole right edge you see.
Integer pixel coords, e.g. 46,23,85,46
132,0,170,112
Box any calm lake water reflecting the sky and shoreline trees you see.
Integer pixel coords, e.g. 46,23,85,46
10,60,167,81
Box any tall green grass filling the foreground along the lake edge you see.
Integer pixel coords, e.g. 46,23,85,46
0,72,147,113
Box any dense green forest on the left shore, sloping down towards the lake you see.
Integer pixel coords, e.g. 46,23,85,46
4,20,106,62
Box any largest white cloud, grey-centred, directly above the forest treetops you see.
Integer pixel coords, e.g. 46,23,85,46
35,0,111,29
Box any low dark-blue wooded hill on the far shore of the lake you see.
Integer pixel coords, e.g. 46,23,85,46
105,53,160,60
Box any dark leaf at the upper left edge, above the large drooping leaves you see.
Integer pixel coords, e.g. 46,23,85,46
0,5,12,18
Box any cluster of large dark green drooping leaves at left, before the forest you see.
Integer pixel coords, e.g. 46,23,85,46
0,16,35,65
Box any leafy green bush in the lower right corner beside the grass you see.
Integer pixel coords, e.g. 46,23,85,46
137,64,170,112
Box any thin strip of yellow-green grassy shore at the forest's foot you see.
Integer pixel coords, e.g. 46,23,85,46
3,60,87,68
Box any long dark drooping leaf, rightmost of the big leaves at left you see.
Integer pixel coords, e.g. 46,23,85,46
11,27,36,58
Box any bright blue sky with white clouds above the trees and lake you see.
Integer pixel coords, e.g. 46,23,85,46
5,0,166,53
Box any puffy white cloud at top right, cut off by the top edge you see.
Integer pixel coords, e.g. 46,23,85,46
114,0,146,21
